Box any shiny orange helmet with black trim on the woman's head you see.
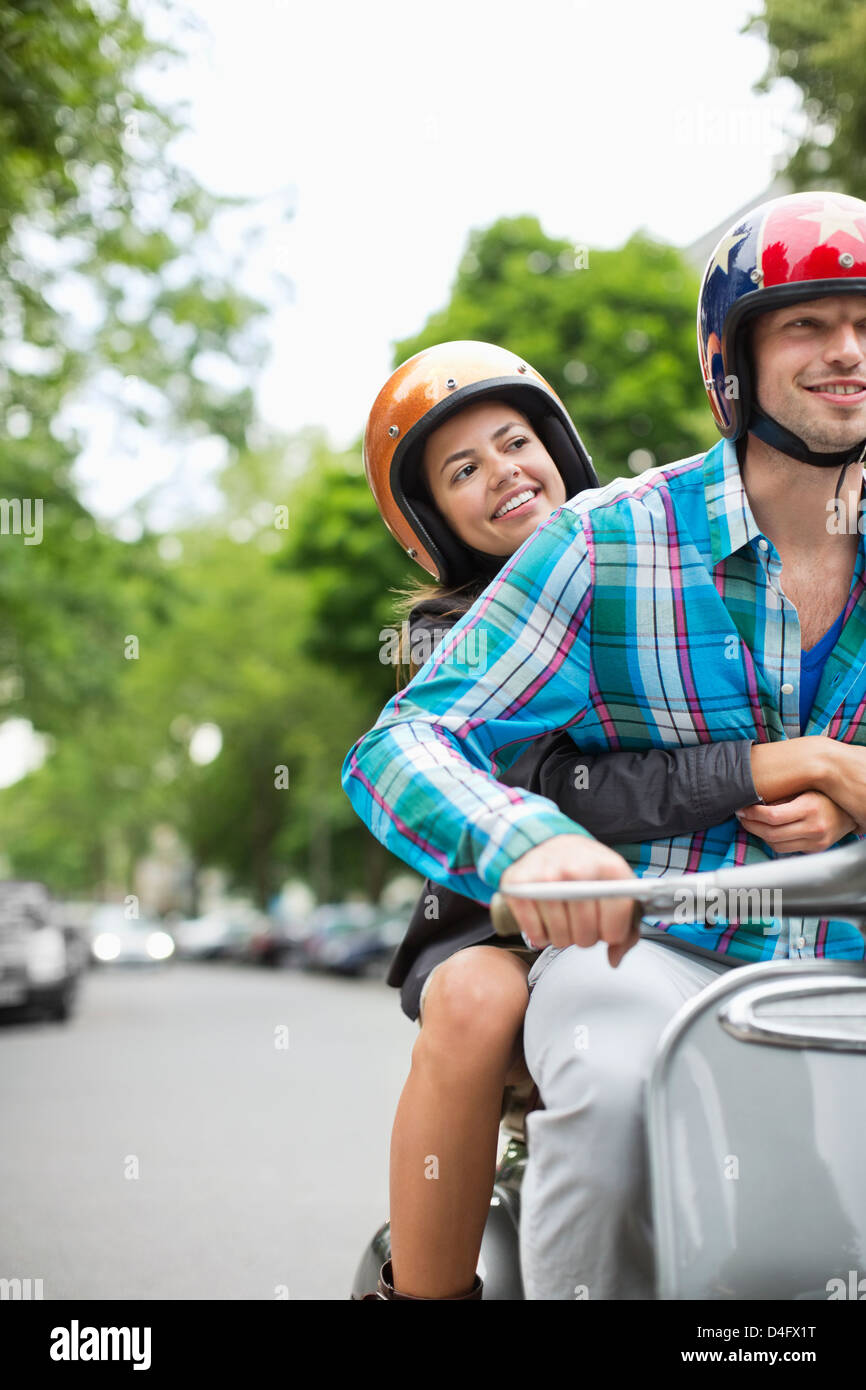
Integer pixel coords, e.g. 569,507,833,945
364,342,598,584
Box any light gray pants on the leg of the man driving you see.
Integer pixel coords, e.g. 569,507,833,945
520,940,728,1300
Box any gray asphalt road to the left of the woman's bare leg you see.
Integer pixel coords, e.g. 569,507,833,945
0,962,417,1300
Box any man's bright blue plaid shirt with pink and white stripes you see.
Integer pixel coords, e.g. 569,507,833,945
342,441,866,962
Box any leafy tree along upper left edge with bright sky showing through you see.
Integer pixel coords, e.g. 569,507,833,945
0,0,263,731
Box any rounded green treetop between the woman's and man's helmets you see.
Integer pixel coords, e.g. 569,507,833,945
395,217,714,480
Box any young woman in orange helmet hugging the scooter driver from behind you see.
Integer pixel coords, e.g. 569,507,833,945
355,342,856,1300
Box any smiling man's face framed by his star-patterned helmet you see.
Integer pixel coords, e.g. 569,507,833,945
752,295,866,453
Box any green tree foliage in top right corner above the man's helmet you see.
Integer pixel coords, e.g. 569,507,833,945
746,0,866,197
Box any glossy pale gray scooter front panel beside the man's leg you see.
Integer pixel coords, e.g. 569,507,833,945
648,960,866,1300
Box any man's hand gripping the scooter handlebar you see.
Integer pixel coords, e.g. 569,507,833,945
499,835,639,966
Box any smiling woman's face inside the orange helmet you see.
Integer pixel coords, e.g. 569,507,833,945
424,400,566,556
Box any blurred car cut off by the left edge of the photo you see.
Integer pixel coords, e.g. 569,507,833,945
0,878,86,1022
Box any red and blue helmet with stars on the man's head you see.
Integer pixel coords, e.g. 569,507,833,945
698,193,866,464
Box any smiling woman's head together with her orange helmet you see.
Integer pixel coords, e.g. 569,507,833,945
364,341,598,594
